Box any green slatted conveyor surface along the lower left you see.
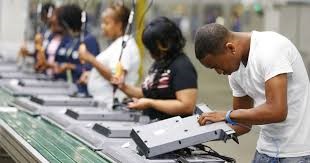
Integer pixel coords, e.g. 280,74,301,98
0,89,109,163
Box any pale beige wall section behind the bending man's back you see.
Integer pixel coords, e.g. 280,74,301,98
264,4,310,55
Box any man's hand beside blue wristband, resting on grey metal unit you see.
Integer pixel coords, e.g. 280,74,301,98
198,111,226,126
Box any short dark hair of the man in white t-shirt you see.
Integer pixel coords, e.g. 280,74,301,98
195,23,229,60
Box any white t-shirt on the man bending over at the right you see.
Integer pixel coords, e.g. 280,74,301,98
229,31,310,157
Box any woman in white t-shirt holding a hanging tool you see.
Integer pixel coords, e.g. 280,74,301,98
79,4,140,109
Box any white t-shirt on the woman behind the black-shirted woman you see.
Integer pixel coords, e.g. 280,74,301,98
87,36,140,109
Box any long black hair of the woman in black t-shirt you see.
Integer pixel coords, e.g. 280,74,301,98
142,17,186,93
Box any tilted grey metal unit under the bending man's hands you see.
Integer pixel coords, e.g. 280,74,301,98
130,115,235,158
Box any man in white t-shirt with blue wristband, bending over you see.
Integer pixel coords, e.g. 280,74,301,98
195,24,310,163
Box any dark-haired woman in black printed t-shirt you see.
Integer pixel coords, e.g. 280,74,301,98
113,17,197,120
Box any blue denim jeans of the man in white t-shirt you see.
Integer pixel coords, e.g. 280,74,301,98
252,151,310,163
